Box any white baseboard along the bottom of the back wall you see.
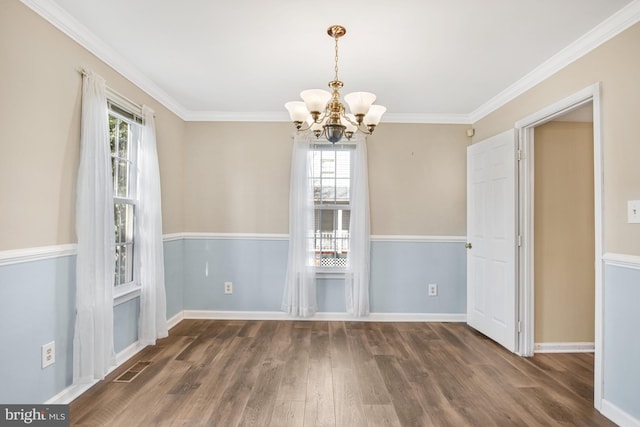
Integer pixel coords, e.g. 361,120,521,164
183,310,467,322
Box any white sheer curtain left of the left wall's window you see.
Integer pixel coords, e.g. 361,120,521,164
73,71,115,383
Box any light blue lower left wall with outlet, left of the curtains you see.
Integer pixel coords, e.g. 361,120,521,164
0,256,76,404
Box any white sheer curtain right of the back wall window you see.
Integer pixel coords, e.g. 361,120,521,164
345,138,371,317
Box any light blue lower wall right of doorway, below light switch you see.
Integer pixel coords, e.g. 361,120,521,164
603,265,640,420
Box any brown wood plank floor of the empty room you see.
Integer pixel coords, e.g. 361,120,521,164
70,320,614,427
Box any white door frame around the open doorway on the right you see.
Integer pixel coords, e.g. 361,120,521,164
515,82,604,410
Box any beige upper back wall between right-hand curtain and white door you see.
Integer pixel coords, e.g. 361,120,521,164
367,123,471,236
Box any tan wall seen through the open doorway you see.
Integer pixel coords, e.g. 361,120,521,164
534,122,595,343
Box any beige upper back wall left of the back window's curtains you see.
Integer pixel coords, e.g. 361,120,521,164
184,122,292,234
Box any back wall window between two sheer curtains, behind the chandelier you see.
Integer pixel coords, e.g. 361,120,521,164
311,144,354,268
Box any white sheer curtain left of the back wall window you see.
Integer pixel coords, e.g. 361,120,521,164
282,135,317,317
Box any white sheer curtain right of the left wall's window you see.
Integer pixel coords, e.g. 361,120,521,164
134,106,168,345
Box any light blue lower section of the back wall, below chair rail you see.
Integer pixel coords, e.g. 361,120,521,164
182,238,466,313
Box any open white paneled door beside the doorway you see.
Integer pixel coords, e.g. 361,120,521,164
467,130,517,352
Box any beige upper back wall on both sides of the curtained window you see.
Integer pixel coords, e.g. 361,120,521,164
184,122,470,236
